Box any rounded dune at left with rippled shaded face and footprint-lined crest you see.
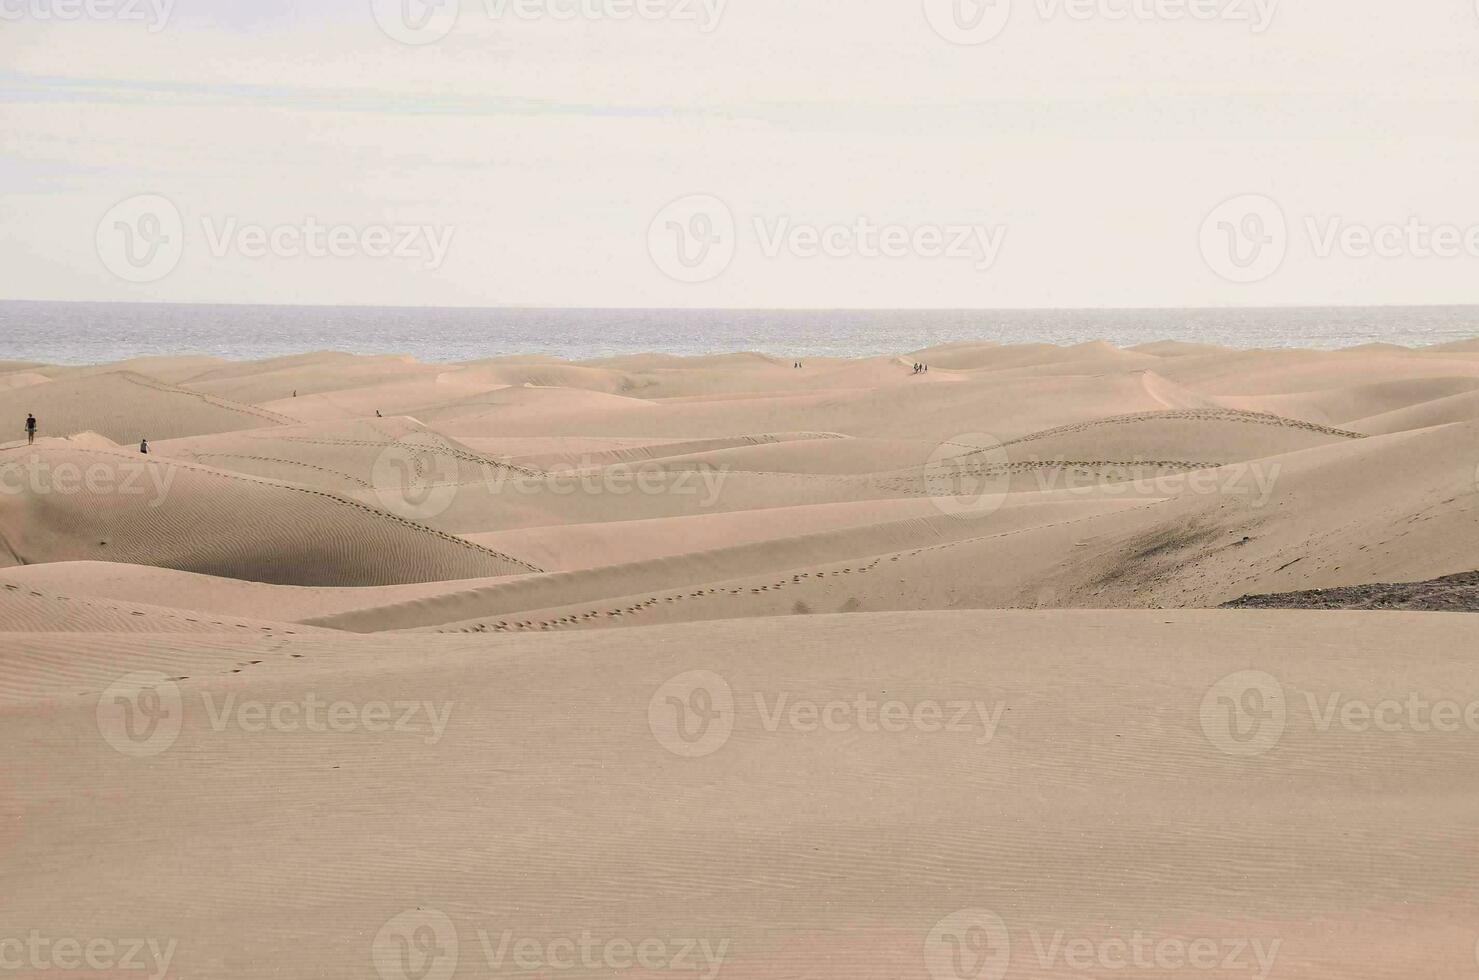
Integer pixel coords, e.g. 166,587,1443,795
0,445,531,587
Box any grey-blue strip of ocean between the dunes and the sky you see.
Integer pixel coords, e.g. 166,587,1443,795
0,302,1479,364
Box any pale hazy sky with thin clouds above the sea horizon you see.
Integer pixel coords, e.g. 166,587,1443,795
0,0,1479,307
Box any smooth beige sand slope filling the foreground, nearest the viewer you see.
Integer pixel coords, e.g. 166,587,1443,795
0,610,1479,980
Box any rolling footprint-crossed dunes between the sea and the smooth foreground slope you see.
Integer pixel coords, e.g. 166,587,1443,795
0,343,1479,614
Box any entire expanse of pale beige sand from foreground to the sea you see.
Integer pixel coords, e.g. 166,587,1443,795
0,343,1479,980
